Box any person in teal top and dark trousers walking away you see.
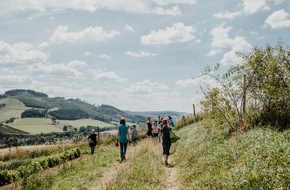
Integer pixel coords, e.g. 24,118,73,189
118,118,129,162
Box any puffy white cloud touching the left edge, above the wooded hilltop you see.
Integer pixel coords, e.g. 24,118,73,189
0,41,49,65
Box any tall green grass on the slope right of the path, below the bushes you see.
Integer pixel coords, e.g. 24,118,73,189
176,121,290,189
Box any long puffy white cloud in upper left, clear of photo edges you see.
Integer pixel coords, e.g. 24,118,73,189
50,26,120,44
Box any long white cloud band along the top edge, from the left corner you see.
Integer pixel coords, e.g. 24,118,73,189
0,0,197,16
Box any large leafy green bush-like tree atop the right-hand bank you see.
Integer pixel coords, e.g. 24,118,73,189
201,42,290,129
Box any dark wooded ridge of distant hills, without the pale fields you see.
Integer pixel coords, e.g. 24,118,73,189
0,89,184,123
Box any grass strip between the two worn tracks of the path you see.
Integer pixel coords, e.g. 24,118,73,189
106,138,166,190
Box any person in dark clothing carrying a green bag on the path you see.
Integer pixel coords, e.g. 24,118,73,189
158,119,172,167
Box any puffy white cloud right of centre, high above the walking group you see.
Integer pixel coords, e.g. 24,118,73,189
141,23,196,46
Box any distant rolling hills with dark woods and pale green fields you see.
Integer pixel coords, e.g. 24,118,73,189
0,89,185,134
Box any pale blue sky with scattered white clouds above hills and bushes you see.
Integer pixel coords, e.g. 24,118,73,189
0,0,290,113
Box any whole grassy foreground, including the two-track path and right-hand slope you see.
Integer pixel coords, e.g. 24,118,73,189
3,123,290,190
